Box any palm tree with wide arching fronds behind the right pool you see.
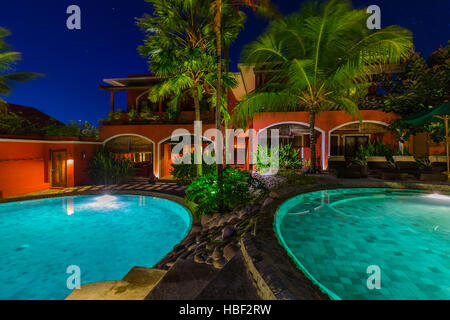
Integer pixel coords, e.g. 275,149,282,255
233,0,412,171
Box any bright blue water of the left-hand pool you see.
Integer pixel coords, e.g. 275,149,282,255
0,195,191,299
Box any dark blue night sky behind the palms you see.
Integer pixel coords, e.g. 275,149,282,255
0,0,450,125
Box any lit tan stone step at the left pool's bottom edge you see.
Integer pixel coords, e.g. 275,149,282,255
66,267,167,300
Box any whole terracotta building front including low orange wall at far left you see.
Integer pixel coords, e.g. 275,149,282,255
0,66,444,198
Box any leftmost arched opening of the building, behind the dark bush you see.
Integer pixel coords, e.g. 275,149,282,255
104,134,155,178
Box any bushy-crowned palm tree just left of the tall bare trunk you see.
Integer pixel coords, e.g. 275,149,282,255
138,0,215,176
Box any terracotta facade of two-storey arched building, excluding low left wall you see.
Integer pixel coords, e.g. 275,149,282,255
100,72,400,178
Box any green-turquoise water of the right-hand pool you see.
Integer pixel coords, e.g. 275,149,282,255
274,189,450,299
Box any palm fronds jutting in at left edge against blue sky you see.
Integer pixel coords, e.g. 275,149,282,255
0,27,39,113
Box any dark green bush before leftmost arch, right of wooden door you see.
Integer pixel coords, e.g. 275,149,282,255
88,148,135,185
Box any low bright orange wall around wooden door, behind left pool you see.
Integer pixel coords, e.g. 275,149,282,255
0,139,98,198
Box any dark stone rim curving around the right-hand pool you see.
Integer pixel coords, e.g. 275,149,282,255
246,177,450,300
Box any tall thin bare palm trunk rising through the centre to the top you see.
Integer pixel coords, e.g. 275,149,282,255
214,0,223,211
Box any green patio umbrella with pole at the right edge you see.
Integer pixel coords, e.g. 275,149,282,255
402,102,450,174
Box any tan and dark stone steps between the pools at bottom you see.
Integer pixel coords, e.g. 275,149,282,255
66,251,260,300
